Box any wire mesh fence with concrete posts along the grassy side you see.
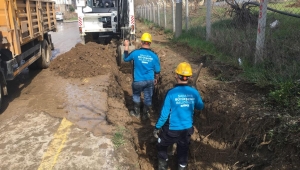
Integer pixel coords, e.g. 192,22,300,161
136,0,300,78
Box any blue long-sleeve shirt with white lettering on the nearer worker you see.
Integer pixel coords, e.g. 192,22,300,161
155,84,204,130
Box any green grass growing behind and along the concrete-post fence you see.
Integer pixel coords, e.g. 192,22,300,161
142,1,300,113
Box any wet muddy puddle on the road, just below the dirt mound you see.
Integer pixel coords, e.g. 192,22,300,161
62,75,113,135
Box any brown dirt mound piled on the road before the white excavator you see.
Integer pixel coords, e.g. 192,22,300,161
50,42,117,78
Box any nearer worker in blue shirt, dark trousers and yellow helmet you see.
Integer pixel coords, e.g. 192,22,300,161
153,62,204,170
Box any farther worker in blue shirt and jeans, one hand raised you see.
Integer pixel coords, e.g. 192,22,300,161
123,33,160,120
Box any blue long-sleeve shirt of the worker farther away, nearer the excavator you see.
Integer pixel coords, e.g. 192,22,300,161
123,48,160,82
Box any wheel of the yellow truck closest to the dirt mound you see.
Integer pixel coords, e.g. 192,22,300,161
36,40,52,69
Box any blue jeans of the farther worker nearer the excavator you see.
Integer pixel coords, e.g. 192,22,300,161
132,80,154,106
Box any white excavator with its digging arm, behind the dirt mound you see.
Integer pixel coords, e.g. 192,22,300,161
76,0,136,72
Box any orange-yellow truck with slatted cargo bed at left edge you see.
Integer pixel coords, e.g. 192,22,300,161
0,0,57,108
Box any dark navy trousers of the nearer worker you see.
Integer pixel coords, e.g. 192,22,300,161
157,126,194,165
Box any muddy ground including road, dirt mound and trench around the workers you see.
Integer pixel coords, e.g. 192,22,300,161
0,21,300,170
